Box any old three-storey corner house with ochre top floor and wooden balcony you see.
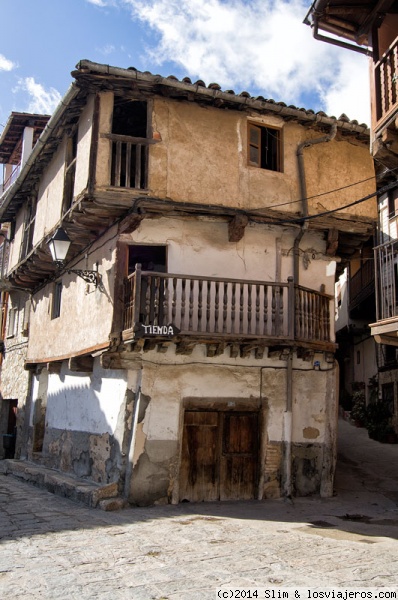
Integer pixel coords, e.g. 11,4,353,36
0,60,376,505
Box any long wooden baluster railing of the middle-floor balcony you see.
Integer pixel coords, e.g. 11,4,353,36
123,265,332,342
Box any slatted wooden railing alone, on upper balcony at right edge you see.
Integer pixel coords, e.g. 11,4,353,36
374,37,398,129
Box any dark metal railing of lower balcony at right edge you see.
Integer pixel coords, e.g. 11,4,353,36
374,240,398,321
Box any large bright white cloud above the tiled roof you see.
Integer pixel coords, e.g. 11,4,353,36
119,0,369,122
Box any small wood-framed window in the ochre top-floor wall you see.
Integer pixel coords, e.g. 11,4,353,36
247,123,282,171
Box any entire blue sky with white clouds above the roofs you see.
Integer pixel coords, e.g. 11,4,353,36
0,0,370,133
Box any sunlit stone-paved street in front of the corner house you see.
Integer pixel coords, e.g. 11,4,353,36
0,423,398,600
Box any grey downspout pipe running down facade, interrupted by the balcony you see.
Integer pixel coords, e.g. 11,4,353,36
282,122,337,499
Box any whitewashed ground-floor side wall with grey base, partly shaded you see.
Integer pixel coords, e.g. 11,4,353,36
29,361,134,484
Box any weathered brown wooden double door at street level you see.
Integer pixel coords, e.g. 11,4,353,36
180,410,259,502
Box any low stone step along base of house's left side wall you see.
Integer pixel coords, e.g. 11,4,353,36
0,458,124,510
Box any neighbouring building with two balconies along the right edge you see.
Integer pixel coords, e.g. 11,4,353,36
305,0,398,432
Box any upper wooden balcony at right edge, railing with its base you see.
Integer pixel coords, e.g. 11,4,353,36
372,37,398,152
